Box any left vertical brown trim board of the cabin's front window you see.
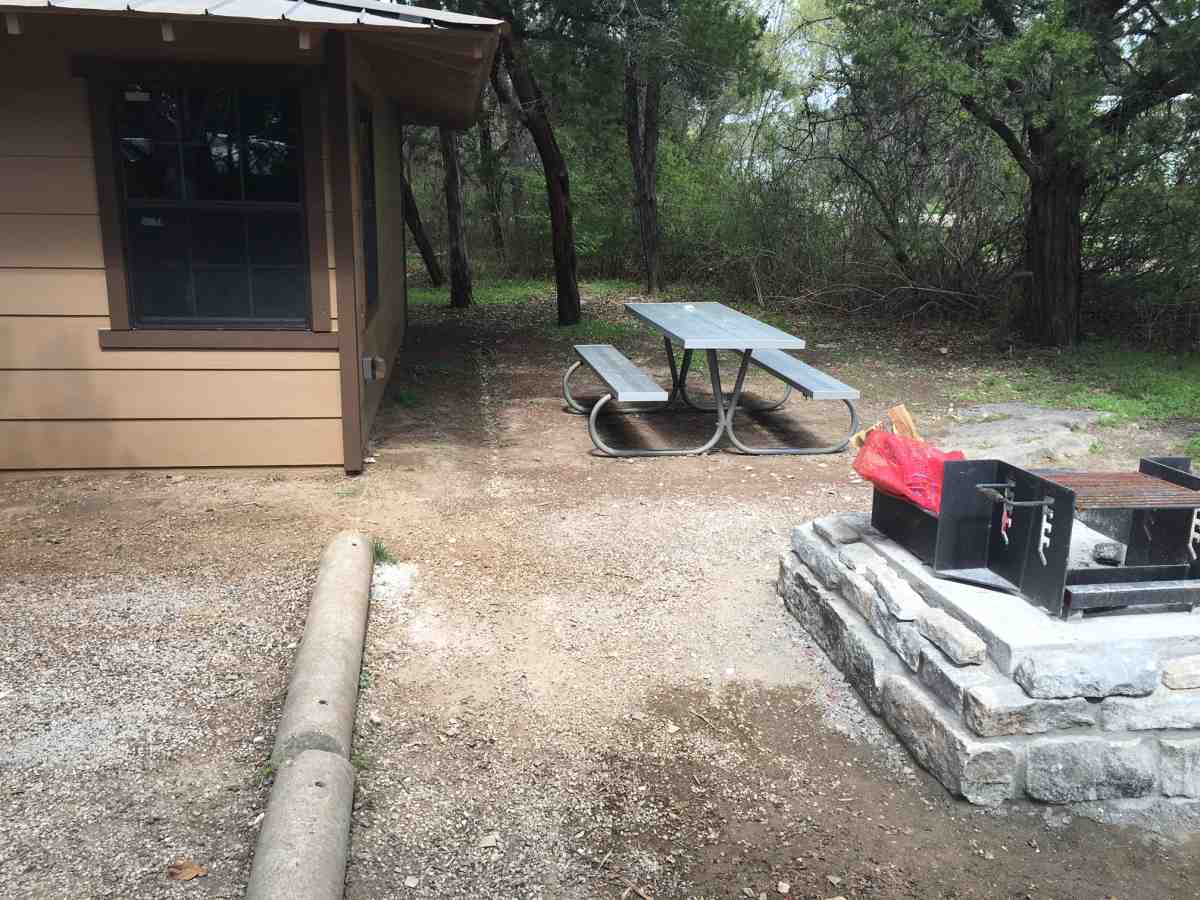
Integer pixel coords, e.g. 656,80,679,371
88,82,130,331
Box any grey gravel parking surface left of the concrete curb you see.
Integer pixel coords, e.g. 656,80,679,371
0,569,312,898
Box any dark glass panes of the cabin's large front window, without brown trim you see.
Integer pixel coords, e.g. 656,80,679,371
114,82,311,329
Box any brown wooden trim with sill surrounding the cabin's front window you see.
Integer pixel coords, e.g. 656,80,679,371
83,58,338,350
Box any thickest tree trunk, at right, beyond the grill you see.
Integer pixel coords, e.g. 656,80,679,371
1020,166,1087,347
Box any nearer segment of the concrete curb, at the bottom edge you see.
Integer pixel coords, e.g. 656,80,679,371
246,750,354,900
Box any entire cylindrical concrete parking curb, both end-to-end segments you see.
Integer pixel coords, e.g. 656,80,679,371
246,532,374,900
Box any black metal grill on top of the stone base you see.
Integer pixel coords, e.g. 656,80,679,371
871,457,1200,618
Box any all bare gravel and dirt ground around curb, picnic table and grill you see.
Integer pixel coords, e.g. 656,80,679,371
0,292,1200,900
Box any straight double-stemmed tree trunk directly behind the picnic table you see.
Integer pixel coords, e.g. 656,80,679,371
625,60,661,295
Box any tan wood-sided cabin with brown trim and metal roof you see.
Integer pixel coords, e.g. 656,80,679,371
0,0,502,473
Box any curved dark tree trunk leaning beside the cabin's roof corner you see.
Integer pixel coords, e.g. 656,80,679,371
484,12,580,325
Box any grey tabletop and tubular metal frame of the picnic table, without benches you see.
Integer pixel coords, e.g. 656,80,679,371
563,302,858,457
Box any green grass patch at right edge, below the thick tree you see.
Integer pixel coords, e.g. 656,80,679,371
968,344,1200,425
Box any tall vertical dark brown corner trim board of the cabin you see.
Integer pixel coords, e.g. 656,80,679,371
325,31,364,473
